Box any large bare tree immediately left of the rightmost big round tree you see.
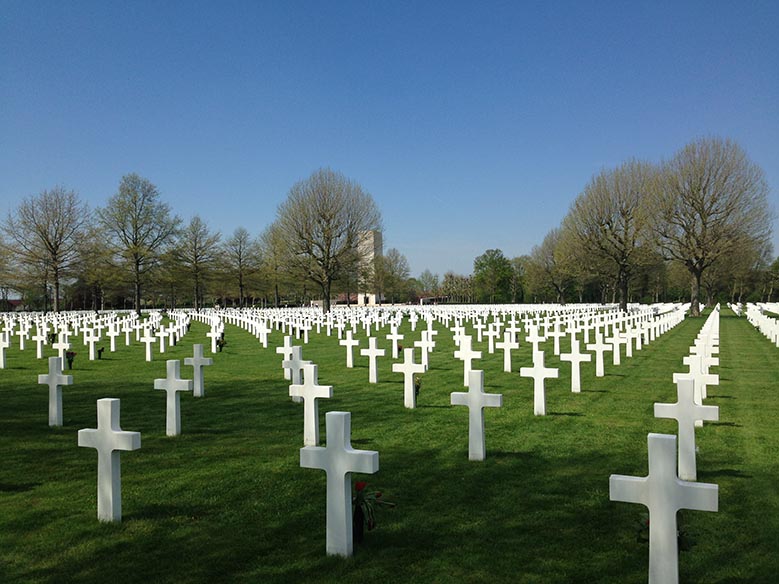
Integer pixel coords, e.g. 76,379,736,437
563,160,656,311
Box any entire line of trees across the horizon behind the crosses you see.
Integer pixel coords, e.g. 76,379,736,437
0,138,779,311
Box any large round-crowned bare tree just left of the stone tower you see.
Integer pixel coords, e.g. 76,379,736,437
277,169,381,312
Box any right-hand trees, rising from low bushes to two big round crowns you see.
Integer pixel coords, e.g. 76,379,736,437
421,138,779,314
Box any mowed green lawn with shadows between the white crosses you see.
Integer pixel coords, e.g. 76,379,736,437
0,311,779,583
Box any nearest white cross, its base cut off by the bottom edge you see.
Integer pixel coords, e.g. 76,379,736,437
609,434,719,584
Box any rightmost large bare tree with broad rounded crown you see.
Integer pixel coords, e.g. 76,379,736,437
653,138,771,316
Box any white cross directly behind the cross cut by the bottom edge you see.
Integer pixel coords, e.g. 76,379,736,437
655,378,719,481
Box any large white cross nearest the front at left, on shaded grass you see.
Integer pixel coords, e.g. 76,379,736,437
78,398,141,521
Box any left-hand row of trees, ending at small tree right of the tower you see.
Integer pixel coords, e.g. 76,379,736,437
0,169,409,311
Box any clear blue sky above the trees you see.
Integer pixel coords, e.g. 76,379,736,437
0,0,779,275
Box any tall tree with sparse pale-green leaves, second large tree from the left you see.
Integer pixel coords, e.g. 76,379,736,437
98,173,180,314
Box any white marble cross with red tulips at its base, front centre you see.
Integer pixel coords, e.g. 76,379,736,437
300,412,379,557
